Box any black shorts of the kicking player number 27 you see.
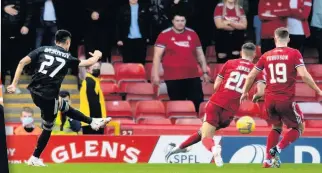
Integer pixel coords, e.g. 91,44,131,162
31,93,58,123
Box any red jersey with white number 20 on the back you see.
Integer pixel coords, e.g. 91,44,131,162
210,59,265,112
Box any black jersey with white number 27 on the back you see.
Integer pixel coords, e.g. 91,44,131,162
28,46,80,99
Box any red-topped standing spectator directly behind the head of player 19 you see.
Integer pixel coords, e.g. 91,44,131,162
258,0,290,54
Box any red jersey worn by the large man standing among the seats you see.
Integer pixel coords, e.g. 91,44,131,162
155,28,202,80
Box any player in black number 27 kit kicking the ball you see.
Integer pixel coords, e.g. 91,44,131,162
7,30,111,166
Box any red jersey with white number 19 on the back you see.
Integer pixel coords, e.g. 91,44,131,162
255,47,304,101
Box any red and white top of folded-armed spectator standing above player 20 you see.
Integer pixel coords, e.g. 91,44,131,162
214,3,246,22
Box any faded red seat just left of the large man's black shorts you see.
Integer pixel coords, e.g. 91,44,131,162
125,83,155,100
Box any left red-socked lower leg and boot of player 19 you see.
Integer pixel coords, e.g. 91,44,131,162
263,124,283,168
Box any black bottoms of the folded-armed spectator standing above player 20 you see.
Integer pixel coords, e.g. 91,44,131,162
216,29,245,56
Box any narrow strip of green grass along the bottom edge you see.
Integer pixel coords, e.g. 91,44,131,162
9,163,322,173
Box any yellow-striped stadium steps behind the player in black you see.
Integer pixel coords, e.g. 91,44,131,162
4,75,79,122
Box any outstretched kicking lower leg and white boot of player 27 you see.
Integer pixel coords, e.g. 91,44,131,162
59,99,112,131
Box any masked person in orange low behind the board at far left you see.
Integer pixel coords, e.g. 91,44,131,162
14,107,41,135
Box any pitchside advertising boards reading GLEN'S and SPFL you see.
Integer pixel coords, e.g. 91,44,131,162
7,136,322,164
